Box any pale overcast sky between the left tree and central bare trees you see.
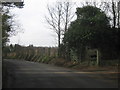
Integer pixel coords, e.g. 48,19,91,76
10,0,111,46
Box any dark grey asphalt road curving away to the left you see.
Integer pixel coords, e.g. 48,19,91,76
3,60,118,88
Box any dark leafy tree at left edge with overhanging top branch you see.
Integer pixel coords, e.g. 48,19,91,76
1,2,24,58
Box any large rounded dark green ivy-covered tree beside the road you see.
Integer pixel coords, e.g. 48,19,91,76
63,6,116,60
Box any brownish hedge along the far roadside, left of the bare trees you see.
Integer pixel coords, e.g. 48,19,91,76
3,44,57,61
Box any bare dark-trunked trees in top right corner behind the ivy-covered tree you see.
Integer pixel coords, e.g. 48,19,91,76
102,0,120,28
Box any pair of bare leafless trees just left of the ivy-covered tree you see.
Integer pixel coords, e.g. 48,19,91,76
45,1,75,56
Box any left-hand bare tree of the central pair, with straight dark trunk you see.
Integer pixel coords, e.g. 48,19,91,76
45,2,63,56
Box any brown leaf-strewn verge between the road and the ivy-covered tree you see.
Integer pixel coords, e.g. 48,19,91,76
41,58,118,72
